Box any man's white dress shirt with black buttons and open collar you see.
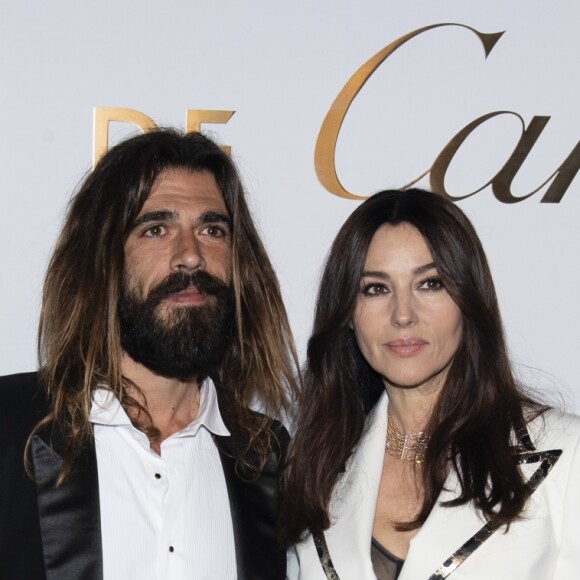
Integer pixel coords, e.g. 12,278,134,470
90,380,237,580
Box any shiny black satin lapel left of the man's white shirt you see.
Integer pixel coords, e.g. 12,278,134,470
30,429,103,580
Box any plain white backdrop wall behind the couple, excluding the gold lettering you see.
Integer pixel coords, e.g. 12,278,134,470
0,0,580,410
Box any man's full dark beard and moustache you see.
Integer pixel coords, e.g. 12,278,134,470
118,271,234,381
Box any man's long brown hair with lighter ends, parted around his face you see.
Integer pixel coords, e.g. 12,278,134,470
35,129,297,482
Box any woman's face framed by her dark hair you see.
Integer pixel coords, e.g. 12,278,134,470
352,223,462,392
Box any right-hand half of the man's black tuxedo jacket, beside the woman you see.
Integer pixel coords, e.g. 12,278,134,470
215,427,288,580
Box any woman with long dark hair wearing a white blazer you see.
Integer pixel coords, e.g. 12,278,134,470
281,189,580,580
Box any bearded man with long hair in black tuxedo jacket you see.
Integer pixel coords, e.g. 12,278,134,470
0,129,296,580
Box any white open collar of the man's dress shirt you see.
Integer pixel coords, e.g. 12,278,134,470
89,378,230,437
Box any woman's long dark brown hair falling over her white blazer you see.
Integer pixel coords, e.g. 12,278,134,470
281,189,544,545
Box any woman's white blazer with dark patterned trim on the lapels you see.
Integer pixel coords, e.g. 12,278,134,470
288,395,580,580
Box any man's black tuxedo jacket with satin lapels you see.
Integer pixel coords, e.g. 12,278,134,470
0,373,288,580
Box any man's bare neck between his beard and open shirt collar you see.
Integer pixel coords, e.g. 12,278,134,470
121,354,200,453
